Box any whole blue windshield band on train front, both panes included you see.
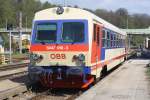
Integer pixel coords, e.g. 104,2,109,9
31,19,88,44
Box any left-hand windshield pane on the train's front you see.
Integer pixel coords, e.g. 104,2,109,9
35,22,57,43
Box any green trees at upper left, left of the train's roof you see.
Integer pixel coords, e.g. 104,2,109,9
0,0,54,28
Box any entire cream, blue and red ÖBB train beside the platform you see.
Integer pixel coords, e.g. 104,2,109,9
29,7,126,88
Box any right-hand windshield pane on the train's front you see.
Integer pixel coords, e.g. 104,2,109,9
61,22,85,43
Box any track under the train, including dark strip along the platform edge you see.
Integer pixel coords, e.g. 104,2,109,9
8,65,124,100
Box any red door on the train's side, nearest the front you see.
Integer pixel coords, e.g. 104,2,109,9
91,24,101,73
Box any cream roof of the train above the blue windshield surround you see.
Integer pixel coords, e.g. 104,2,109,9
34,7,126,35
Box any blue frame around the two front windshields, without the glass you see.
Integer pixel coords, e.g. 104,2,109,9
31,20,88,44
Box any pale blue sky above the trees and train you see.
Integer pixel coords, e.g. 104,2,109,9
40,0,150,15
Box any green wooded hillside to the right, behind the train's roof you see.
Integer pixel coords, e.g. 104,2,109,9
95,8,150,29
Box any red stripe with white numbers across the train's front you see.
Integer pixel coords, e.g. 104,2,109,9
30,44,89,52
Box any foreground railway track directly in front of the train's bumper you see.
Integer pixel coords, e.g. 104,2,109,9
7,86,83,100
